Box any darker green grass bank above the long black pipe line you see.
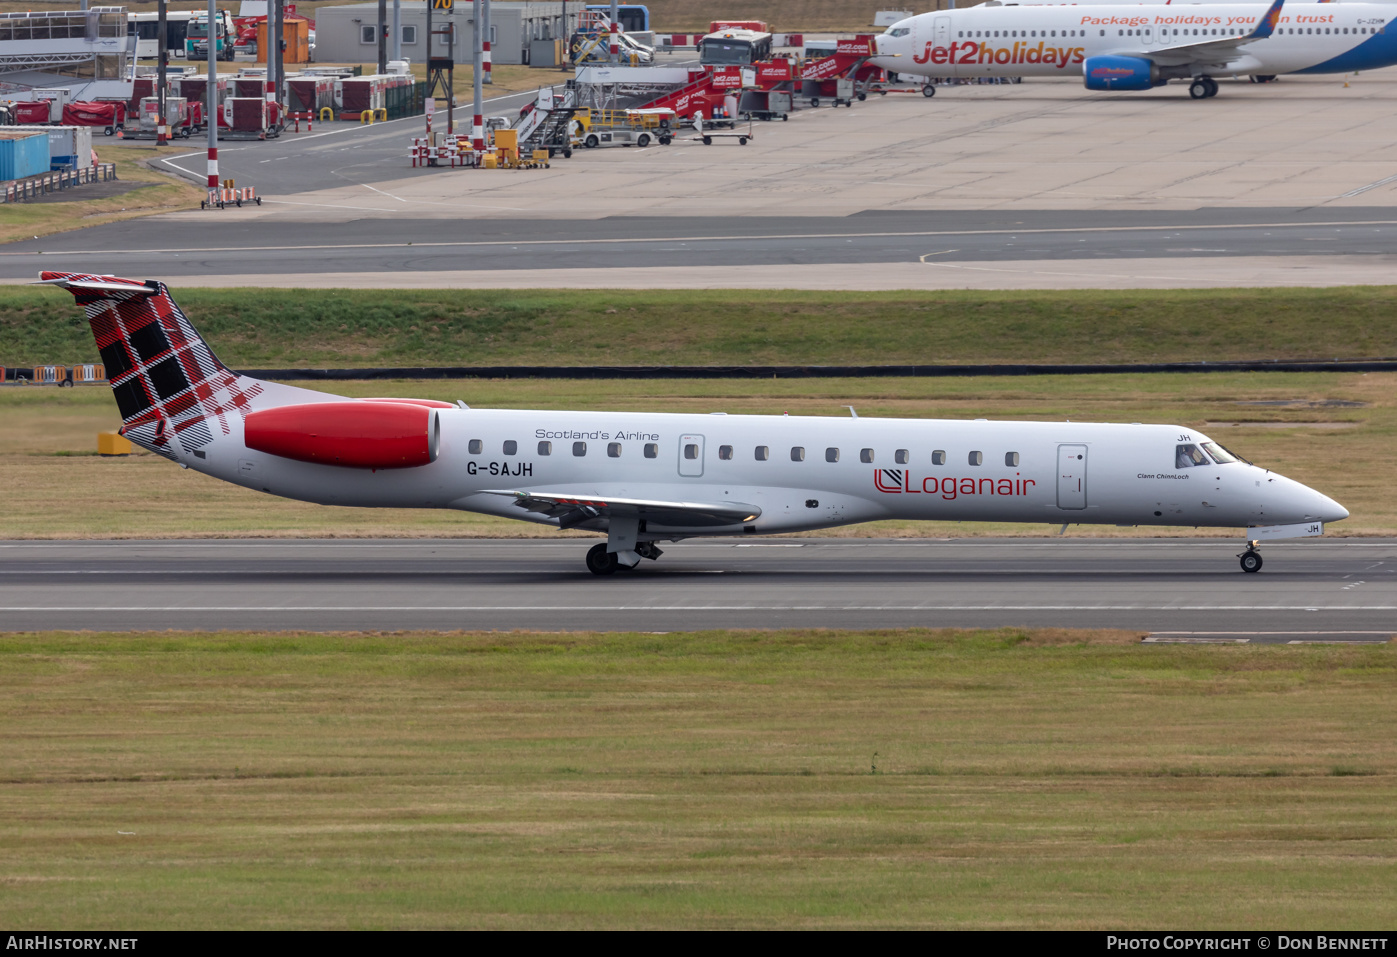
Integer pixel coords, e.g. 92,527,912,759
0,286,1397,367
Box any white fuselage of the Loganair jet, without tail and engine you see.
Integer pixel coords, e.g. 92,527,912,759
176,397,1348,539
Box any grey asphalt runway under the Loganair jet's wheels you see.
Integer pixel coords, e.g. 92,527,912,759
0,538,1397,643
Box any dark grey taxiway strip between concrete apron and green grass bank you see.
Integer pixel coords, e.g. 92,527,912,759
0,207,1397,279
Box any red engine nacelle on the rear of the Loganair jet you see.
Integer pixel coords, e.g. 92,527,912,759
243,401,441,468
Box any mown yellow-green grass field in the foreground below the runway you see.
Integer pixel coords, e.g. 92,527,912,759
0,630,1397,930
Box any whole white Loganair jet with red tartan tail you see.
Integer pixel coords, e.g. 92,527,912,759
41,272,1348,574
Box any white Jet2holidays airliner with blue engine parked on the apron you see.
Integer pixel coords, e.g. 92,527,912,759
872,0,1397,99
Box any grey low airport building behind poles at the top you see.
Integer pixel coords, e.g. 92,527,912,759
316,0,581,64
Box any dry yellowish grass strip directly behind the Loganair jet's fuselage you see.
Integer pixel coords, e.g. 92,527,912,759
0,373,1397,538
